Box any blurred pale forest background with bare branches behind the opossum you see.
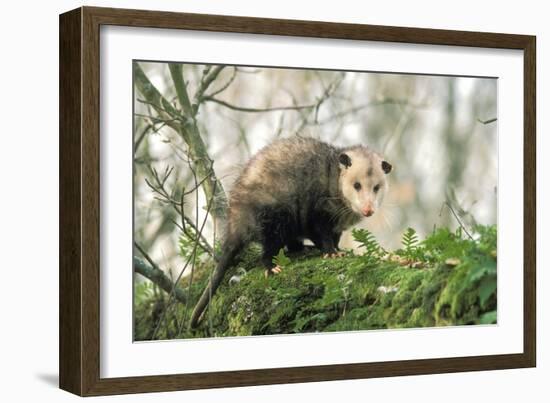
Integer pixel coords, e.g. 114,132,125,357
134,62,498,280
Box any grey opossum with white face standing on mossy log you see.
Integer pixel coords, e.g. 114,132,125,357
190,136,392,328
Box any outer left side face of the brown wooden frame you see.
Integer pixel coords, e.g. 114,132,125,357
59,10,83,394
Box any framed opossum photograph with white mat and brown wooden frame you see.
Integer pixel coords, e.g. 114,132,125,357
60,7,536,396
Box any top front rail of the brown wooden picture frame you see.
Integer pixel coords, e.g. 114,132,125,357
85,7,529,49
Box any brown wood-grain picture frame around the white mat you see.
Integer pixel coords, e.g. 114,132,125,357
59,7,536,396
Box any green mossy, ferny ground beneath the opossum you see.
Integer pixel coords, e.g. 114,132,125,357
136,227,496,339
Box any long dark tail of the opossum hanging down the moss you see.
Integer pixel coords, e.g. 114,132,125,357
189,240,243,328
